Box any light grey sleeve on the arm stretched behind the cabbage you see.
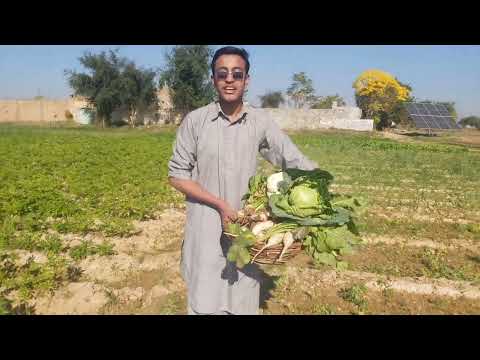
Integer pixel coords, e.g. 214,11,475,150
259,119,318,170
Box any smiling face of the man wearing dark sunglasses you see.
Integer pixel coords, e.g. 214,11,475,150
212,55,249,103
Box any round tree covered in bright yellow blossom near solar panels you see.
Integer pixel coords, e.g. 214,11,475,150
353,70,412,128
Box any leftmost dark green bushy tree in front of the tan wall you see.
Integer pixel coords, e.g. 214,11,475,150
65,50,126,127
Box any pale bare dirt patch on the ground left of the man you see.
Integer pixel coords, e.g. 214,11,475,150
32,210,185,314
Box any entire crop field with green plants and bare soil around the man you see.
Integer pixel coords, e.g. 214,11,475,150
0,124,480,315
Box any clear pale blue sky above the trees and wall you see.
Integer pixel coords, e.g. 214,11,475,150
0,44,480,118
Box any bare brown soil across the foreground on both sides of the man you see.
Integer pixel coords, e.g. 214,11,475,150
19,209,480,315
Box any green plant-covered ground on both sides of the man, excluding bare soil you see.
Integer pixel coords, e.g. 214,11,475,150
0,125,480,314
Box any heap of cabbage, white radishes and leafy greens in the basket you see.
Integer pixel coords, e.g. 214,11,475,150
226,169,365,269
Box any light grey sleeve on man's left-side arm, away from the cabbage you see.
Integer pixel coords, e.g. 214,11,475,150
168,115,197,180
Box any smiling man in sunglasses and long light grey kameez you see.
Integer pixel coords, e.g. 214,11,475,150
168,46,316,314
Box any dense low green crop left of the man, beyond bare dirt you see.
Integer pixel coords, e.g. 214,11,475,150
0,126,182,247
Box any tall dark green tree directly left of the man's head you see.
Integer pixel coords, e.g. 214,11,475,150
160,45,215,117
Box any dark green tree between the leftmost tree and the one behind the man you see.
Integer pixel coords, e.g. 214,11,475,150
120,62,158,127
